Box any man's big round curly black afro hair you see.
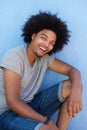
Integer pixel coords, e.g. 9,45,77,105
22,12,70,55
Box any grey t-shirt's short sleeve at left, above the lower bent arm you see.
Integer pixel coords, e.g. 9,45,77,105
0,49,22,76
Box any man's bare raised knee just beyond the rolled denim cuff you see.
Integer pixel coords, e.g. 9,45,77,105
62,80,71,98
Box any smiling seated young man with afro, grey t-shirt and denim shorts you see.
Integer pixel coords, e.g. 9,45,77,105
0,12,82,130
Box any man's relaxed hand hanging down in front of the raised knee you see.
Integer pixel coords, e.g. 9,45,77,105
67,88,82,117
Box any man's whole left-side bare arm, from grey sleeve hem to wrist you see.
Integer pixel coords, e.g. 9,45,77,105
4,69,45,121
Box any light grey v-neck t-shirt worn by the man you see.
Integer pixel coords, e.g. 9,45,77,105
0,45,54,114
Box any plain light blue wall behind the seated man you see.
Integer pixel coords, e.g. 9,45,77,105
0,0,87,130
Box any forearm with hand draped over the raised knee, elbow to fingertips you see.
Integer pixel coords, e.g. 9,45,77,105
67,68,82,117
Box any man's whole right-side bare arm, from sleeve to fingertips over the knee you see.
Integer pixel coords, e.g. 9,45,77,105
49,58,82,117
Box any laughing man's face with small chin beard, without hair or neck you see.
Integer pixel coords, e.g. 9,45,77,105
31,29,57,57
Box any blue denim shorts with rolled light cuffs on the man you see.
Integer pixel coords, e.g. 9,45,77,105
0,82,65,130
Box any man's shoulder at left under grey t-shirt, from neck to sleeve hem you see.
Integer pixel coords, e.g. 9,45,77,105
0,46,25,74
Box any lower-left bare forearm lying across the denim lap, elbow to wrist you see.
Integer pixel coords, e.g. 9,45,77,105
8,100,45,122
